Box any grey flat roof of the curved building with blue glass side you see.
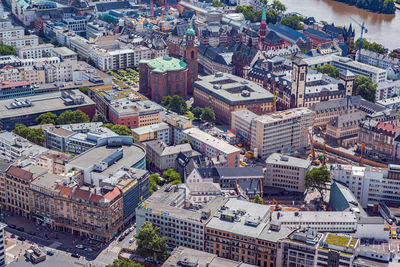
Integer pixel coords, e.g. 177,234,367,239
68,145,146,175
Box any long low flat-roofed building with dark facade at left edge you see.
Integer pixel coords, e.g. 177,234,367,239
0,90,95,131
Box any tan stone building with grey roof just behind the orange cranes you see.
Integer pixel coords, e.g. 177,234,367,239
326,112,365,147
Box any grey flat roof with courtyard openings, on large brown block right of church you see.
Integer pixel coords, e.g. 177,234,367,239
194,73,274,105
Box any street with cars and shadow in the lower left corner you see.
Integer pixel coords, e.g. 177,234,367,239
5,214,136,267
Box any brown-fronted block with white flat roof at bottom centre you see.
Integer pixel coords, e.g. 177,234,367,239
204,199,291,266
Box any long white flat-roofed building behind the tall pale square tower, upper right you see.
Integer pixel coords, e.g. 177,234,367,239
303,55,387,84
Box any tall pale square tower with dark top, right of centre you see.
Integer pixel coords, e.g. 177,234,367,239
292,59,308,108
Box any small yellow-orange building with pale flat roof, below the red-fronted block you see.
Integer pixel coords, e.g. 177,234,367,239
132,122,170,144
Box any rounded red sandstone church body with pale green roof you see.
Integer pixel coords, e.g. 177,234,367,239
139,56,190,103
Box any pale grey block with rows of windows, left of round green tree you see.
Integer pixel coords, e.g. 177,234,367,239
264,153,311,193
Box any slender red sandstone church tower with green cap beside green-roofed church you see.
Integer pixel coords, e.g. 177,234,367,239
184,27,198,95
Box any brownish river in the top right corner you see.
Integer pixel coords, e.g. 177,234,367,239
280,0,400,49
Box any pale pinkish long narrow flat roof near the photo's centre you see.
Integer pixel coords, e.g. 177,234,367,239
183,128,240,154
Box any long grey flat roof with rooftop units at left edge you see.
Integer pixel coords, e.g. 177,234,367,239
0,90,95,119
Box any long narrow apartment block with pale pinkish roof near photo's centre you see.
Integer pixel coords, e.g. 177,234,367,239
179,128,240,167
